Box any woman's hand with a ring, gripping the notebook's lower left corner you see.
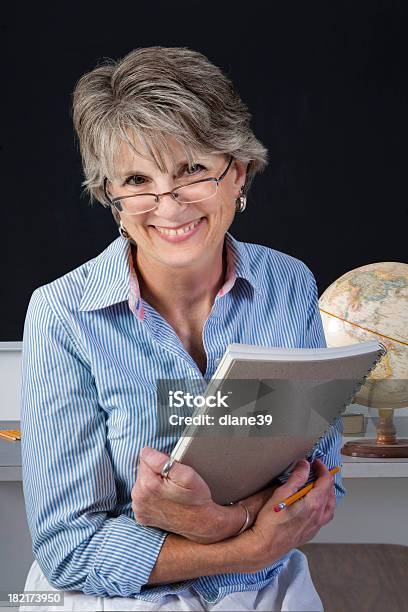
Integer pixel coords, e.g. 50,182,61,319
131,447,275,544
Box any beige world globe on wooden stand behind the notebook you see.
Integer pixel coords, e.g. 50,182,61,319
319,261,408,457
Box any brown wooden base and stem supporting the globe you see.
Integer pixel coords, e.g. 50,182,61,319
341,409,408,459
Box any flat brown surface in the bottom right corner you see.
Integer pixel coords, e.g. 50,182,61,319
300,543,408,612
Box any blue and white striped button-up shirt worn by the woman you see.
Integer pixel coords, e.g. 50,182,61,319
21,232,345,603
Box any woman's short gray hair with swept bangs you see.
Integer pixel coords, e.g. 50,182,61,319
72,46,268,221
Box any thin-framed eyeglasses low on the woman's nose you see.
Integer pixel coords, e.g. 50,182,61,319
103,156,234,215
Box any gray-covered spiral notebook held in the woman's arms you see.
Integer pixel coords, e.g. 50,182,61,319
162,341,387,504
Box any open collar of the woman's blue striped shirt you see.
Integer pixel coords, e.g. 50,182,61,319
78,232,264,319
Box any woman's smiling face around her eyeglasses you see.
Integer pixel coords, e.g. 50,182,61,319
103,139,246,267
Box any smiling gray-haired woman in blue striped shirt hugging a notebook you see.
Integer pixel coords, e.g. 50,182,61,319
21,47,344,610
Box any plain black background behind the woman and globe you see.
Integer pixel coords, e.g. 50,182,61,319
0,0,408,341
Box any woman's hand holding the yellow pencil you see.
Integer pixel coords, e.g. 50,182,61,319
239,459,336,572
